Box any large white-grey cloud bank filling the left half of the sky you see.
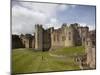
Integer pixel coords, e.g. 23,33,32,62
12,2,57,34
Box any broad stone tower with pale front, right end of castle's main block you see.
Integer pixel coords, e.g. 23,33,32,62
65,23,81,47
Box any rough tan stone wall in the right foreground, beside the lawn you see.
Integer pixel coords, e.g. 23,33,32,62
85,30,96,68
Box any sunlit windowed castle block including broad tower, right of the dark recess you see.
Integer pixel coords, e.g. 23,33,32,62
47,24,82,48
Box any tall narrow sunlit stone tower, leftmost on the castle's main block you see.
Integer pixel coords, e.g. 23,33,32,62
35,24,43,50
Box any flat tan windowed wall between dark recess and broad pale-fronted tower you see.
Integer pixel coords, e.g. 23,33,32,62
51,29,65,48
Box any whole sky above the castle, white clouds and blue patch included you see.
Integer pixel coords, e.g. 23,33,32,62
12,0,96,34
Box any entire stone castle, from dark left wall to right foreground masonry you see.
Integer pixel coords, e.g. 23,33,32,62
12,23,96,68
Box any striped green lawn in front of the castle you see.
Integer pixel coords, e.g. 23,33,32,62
12,46,84,73
